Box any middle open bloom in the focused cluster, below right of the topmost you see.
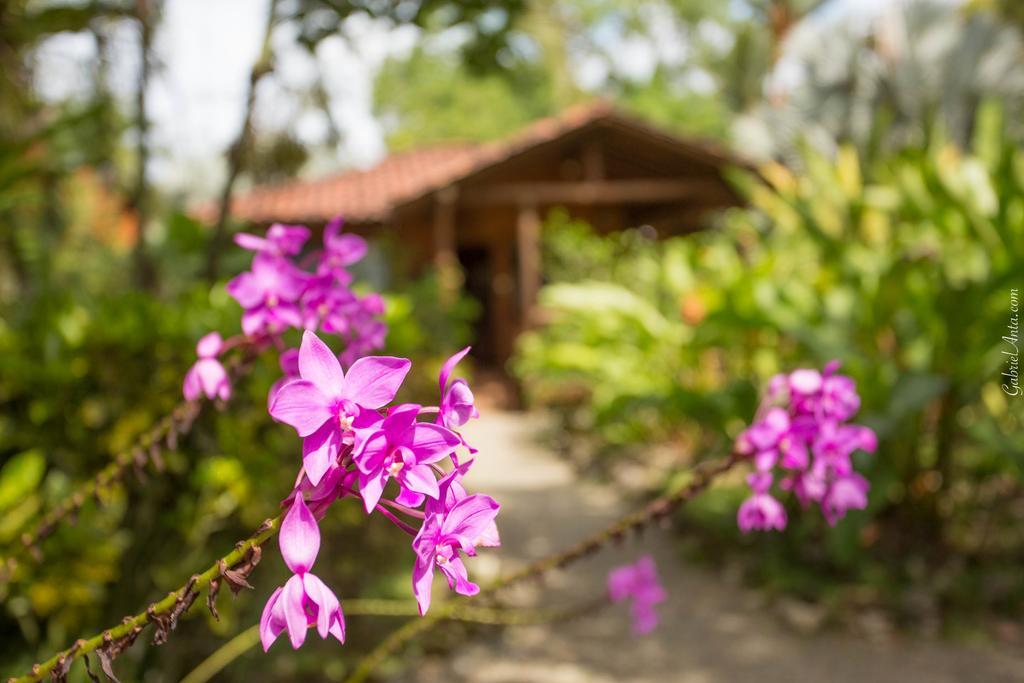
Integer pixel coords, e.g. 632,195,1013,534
352,405,461,512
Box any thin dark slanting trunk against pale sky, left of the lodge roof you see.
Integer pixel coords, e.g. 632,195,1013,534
206,0,278,281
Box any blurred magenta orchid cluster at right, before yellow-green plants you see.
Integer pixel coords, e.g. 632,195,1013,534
736,361,878,533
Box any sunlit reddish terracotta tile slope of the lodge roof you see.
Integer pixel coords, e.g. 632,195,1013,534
195,100,733,223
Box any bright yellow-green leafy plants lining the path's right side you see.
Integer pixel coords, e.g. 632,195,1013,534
516,108,1024,613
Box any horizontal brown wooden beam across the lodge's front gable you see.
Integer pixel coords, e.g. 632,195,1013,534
463,178,725,206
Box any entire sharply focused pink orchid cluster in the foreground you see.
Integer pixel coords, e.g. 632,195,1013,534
260,331,500,649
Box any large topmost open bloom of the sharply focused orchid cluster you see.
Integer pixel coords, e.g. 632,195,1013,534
270,331,412,485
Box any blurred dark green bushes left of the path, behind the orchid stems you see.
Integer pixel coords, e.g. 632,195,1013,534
0,202,475,680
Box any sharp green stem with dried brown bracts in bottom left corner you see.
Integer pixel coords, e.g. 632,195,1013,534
8,515,282,683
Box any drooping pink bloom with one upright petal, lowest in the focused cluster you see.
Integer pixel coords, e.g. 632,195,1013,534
259,494,345,651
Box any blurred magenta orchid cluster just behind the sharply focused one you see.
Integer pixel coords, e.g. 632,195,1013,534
182,218,387,400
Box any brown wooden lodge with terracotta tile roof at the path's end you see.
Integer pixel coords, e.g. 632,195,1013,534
218,102,738,364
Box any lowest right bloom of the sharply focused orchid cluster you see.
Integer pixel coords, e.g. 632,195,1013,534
413,494,501,614
